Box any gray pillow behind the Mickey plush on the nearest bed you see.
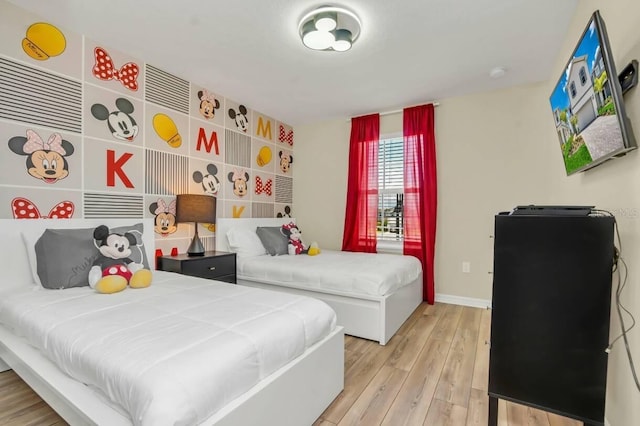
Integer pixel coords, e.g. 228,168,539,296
35,223,149,289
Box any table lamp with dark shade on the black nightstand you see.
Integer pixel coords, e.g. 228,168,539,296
176,194,216,256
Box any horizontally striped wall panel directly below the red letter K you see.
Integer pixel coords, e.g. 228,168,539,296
84,192,144,219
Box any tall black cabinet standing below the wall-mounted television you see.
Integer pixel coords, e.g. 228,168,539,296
489,214,614,425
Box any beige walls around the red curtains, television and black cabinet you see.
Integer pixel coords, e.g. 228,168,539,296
294,0,640,426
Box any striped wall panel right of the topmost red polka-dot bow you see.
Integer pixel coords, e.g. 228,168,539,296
144,64,189,115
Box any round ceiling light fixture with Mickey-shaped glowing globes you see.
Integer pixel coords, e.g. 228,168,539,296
298,6,360,52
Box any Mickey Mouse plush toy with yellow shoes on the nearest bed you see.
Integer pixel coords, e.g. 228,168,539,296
89,225,151,294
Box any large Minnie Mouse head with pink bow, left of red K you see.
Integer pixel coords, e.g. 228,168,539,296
9,129,74,183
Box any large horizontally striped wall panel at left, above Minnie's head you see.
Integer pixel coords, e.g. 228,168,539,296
0,57,82,133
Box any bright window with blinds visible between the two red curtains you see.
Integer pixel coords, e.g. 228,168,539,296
377,136,404,241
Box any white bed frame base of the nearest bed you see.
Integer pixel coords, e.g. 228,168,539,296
0,326,344,426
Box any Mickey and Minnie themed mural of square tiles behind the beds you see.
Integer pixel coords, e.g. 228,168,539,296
0,0,294,253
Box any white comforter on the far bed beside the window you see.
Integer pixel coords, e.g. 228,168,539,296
237,250,422,296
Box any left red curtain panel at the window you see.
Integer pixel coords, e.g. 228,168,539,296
342,114,380,253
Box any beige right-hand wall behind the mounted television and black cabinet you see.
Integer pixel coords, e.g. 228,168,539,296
545,0,640,426
